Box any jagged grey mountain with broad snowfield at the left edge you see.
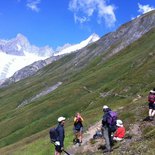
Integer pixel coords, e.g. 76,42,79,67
0,34,53,80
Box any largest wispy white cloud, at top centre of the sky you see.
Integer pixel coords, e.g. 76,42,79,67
69,0,116,27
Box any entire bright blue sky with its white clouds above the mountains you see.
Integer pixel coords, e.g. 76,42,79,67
0,0,155,49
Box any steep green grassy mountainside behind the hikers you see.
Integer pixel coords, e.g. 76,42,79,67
0,29,155,154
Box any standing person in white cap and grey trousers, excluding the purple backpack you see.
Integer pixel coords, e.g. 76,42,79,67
102,105,117,153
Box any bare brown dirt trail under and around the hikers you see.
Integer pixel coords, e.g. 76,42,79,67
67,117,155,155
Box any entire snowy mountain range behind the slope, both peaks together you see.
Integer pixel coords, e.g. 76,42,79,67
0,33,99,83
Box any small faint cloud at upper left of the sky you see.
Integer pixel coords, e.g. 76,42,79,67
26,0,41,12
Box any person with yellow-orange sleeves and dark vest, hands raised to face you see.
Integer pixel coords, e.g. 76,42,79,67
74,113,83,146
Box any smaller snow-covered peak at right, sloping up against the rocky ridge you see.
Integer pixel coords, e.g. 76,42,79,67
54,33,100,56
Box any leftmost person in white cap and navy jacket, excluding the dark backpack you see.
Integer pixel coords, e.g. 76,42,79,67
55,117,65,155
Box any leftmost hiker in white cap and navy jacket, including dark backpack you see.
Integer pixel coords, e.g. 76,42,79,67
50,116,65,155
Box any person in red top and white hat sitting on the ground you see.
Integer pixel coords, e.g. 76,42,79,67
113,120,125,141
